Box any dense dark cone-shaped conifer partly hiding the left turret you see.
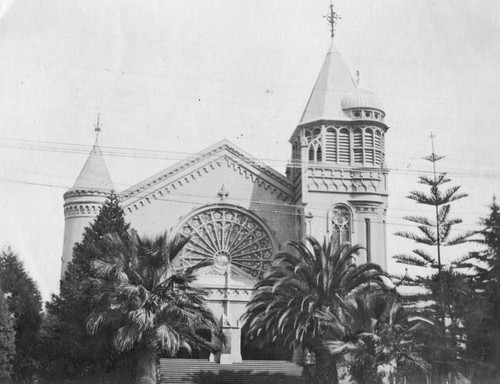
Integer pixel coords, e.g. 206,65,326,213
39,194,129,377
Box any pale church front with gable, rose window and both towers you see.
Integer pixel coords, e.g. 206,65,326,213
62,37,388,362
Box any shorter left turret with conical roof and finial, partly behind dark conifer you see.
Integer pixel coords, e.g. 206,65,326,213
61,117,114,279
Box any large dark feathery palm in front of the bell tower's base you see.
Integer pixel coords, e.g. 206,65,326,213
244,237,385,383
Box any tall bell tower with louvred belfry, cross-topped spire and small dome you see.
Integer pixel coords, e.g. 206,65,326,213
287,10,389,269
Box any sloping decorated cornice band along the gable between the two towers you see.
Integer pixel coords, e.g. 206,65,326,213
120,140,293,208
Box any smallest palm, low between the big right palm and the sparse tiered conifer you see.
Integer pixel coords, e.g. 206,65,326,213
320,290,433,384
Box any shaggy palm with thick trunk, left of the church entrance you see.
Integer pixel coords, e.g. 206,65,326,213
87,232,221,384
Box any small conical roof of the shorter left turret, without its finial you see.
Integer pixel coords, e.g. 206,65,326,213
72,138,114,192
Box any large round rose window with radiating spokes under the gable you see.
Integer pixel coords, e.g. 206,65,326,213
181,207,273,278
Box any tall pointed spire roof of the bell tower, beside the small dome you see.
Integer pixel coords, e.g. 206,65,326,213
300,40,356,124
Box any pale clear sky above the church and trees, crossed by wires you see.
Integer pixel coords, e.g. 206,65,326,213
0,0,500,300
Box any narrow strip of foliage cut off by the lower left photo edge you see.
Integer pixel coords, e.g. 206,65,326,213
0,289,16,382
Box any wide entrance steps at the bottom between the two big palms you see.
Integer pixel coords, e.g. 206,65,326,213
158,359,305,384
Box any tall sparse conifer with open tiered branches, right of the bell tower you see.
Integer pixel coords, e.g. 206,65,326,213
394,151,472,380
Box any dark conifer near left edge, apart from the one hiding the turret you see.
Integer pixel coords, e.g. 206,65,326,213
0,248,42,380
